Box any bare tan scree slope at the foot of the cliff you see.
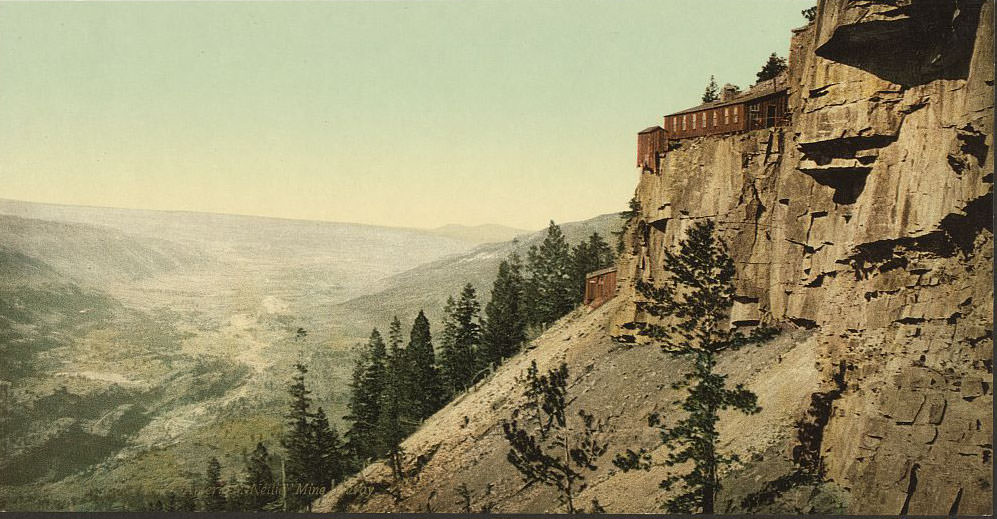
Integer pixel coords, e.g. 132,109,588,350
315,301,817,513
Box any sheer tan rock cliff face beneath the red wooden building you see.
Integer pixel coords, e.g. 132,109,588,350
613,0,994,514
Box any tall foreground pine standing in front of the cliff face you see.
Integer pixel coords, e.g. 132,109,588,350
614,221,775,514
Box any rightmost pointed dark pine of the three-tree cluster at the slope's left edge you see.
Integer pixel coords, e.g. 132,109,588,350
406,310,443,421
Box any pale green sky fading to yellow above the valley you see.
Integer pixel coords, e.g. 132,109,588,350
0,0,814,229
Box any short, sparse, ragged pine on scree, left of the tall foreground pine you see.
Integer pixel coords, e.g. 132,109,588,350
502,361,606,514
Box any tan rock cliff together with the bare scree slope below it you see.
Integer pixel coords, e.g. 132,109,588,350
317,0,994,515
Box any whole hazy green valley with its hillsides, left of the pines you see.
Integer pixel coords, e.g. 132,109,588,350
0,201,618,510
